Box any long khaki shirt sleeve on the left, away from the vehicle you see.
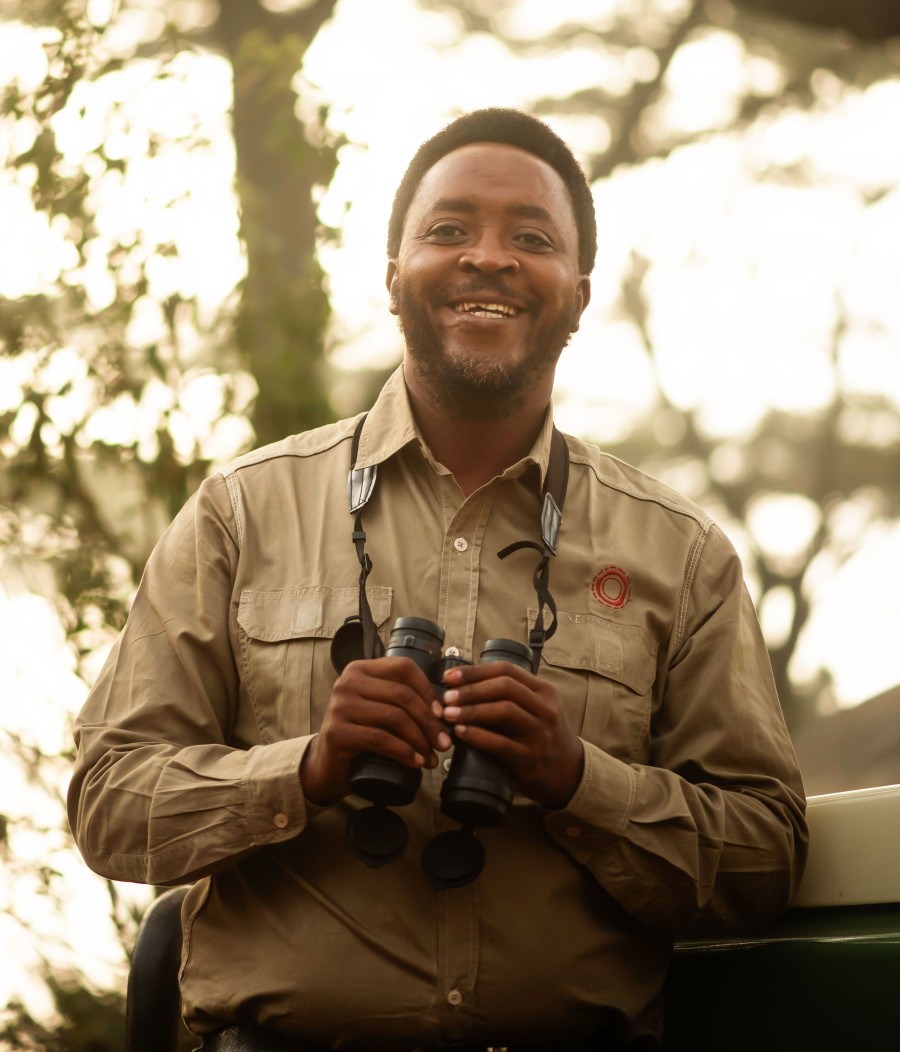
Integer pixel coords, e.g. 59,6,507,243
68,476,309,885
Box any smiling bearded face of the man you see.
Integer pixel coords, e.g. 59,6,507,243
387,143,590,416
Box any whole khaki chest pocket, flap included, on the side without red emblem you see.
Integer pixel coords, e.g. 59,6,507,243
238,585,392,744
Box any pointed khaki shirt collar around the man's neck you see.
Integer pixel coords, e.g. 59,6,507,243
356,365,553,485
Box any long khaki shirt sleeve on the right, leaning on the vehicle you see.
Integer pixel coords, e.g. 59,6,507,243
546,527,807,934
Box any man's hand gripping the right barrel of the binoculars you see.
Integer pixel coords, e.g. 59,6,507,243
434,662,585,810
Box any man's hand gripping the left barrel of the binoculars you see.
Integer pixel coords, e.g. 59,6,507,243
300,658,451,804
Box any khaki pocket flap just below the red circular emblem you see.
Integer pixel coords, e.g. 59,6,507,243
528,609,658,694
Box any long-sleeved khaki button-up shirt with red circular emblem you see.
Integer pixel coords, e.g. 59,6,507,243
69,371,805,1049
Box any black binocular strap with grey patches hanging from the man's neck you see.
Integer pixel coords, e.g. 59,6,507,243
347,417,569,672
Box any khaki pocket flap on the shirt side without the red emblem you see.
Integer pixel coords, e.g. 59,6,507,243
238,585,392,643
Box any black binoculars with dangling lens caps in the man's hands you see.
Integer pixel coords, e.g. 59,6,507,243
347,618,532,888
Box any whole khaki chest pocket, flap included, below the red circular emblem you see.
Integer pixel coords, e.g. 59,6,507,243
528,610,657,763
